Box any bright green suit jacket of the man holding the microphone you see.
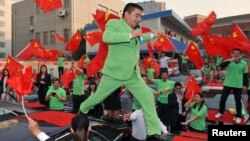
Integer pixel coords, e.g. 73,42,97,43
102,19,150,80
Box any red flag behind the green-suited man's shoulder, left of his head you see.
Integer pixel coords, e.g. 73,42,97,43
92,10,120,31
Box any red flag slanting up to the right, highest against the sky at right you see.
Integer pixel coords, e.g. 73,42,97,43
191,11,216,37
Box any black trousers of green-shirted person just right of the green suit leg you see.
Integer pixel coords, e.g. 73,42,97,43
157,101,170,127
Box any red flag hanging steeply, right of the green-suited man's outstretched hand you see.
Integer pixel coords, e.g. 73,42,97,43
185,42,204,69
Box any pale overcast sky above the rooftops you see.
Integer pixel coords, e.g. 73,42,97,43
12,0,250,18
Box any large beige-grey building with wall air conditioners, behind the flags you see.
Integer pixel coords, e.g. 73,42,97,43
12,0,125,56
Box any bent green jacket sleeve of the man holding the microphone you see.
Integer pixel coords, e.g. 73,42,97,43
102,20,130,44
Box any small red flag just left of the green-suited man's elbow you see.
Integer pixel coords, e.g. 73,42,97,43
83,31,102,47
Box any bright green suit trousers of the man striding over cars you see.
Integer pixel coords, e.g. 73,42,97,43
80,72,161,135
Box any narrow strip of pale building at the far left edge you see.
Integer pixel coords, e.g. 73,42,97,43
0,0,12,60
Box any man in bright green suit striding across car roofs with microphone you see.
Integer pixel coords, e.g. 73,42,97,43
80,3,161,138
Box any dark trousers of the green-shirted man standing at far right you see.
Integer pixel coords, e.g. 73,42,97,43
219,86,242,117
